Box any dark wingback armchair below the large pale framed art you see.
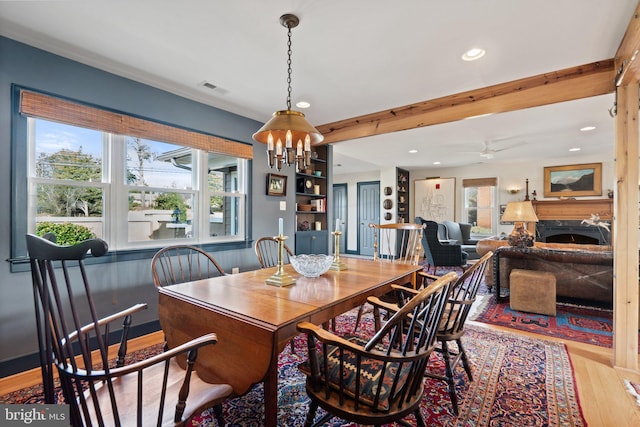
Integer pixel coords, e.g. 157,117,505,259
416,217,469,274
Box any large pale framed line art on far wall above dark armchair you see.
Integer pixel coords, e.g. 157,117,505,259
414,178,456,222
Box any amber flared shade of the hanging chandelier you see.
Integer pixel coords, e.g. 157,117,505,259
253,110,324,144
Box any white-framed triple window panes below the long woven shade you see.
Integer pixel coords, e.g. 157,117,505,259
28,118,247,249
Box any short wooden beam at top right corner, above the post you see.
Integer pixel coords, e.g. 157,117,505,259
615,3,640,86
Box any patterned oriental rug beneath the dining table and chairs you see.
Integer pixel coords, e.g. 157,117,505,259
0,312,587,427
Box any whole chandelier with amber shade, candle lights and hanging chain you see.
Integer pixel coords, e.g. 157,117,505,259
253,14,324,170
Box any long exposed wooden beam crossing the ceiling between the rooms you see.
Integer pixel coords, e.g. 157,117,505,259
316,59,615,144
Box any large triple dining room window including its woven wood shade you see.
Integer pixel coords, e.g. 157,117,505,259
14,91,252,256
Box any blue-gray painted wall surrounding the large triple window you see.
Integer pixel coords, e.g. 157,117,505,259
0,37,295,377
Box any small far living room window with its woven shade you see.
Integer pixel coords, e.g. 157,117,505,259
462,178,497,237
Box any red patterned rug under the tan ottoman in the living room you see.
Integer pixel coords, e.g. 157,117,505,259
473,297,613,347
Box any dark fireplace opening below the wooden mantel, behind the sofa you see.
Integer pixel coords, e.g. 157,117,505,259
536,220,611,245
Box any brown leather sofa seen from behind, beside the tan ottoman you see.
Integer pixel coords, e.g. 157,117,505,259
476,239,613,307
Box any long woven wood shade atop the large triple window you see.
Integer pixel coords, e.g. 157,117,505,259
20,90,253,159
